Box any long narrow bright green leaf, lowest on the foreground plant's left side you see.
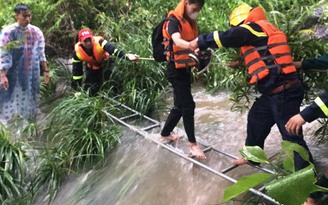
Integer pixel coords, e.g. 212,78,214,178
223,173,277,202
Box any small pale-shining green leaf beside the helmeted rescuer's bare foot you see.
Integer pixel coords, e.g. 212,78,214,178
239,146,269,164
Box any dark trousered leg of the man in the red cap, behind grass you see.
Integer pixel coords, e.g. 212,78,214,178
83,68,103,96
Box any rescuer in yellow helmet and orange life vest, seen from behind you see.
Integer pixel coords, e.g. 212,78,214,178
191,4,312,170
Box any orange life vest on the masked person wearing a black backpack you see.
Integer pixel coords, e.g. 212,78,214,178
162,0,198,69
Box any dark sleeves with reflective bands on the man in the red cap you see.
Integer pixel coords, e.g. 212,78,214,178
73,39,125,80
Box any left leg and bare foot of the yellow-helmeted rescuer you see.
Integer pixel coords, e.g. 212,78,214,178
233,95,275,165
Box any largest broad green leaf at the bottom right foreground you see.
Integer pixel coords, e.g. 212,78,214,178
265,165,317,205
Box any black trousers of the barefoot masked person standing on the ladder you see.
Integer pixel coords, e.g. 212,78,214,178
161,69,196,143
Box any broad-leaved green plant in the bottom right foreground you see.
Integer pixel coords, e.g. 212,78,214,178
223,141,328,205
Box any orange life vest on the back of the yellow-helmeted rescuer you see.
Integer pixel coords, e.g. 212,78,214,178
241,20,296,84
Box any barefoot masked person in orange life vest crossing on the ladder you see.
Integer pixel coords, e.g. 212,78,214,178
161,0,206,159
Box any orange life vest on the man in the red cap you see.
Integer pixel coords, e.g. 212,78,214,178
75,36,109,70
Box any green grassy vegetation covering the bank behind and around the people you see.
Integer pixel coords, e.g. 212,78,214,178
0,0,327,204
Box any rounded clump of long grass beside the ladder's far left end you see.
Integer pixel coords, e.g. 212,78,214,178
48,92,120,169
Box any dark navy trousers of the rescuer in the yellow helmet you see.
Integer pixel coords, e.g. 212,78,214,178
245,84,313,170
